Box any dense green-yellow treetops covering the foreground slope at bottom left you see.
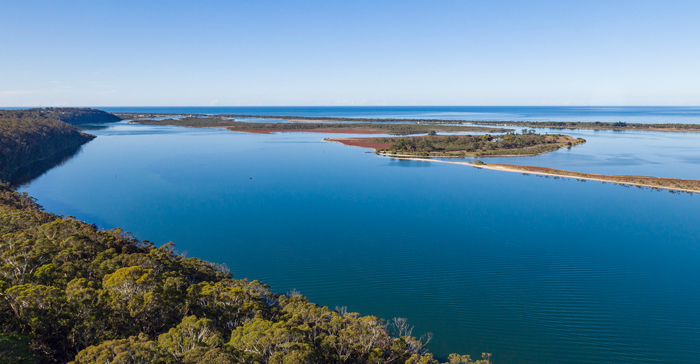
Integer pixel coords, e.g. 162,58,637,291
0,187,489,364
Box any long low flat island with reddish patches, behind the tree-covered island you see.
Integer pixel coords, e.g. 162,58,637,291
129,117,513,135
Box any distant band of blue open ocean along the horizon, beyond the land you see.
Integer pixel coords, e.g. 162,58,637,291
101,106,700,124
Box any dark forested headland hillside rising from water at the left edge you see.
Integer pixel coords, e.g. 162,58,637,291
0,109,94,181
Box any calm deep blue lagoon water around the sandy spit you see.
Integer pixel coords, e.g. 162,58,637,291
15,109,700,363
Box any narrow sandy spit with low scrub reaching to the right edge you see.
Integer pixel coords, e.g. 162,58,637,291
397,157,700,193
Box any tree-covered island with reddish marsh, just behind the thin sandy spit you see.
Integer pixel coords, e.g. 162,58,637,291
329,130,586,157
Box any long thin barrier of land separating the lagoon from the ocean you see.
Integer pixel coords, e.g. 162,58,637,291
113,112,700,132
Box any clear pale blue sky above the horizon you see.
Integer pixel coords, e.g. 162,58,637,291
0,0,700,106
